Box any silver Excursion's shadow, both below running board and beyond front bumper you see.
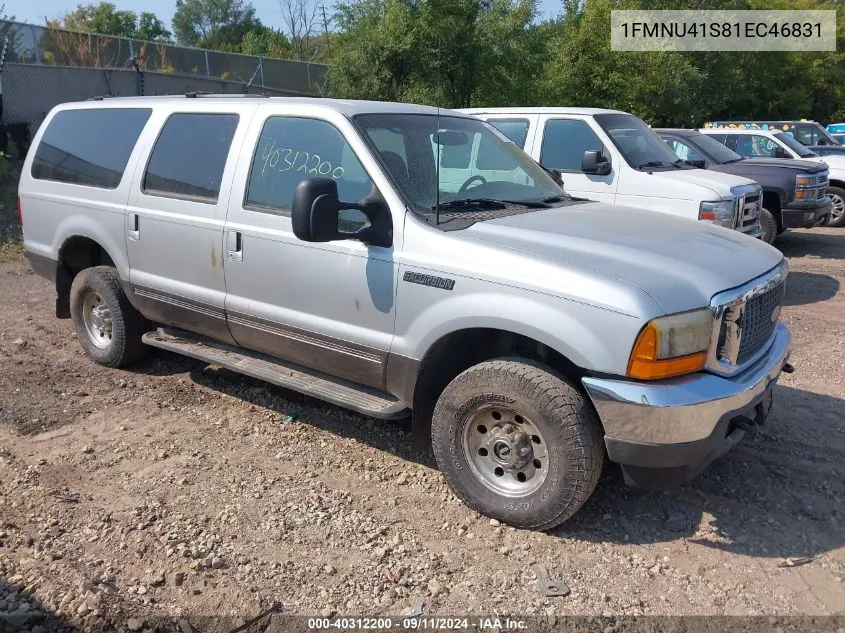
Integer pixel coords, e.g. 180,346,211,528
132,346,845,558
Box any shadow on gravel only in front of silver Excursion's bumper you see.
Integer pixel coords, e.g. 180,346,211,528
556,386,845,562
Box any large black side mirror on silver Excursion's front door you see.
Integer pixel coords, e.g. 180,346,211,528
291,178,393,247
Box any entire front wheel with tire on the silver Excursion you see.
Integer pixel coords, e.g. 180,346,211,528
431,358,604,530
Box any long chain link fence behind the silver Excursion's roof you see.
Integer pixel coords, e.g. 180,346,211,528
0,21,328,153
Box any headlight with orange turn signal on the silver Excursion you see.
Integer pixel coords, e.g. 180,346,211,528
628,308,713,380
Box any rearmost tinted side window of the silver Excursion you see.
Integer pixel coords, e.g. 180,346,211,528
32,108,152,189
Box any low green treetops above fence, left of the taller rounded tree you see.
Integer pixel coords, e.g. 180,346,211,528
51,2,170,40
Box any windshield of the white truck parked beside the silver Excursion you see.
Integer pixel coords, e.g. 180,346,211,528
595,114,686,169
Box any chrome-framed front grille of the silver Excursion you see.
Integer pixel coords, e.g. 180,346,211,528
708,262,787,374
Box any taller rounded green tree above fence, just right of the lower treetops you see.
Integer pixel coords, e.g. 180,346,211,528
173,0,261,50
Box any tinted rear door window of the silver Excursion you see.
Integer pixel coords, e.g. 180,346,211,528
142,113,238,203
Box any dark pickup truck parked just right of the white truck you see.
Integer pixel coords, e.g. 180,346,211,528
655,129,831,244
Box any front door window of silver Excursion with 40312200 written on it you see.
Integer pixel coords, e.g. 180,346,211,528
244,116,374,232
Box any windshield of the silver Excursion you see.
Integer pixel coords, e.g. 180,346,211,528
354,114,570,219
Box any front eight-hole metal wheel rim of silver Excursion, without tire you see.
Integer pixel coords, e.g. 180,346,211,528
463,407,549,498
